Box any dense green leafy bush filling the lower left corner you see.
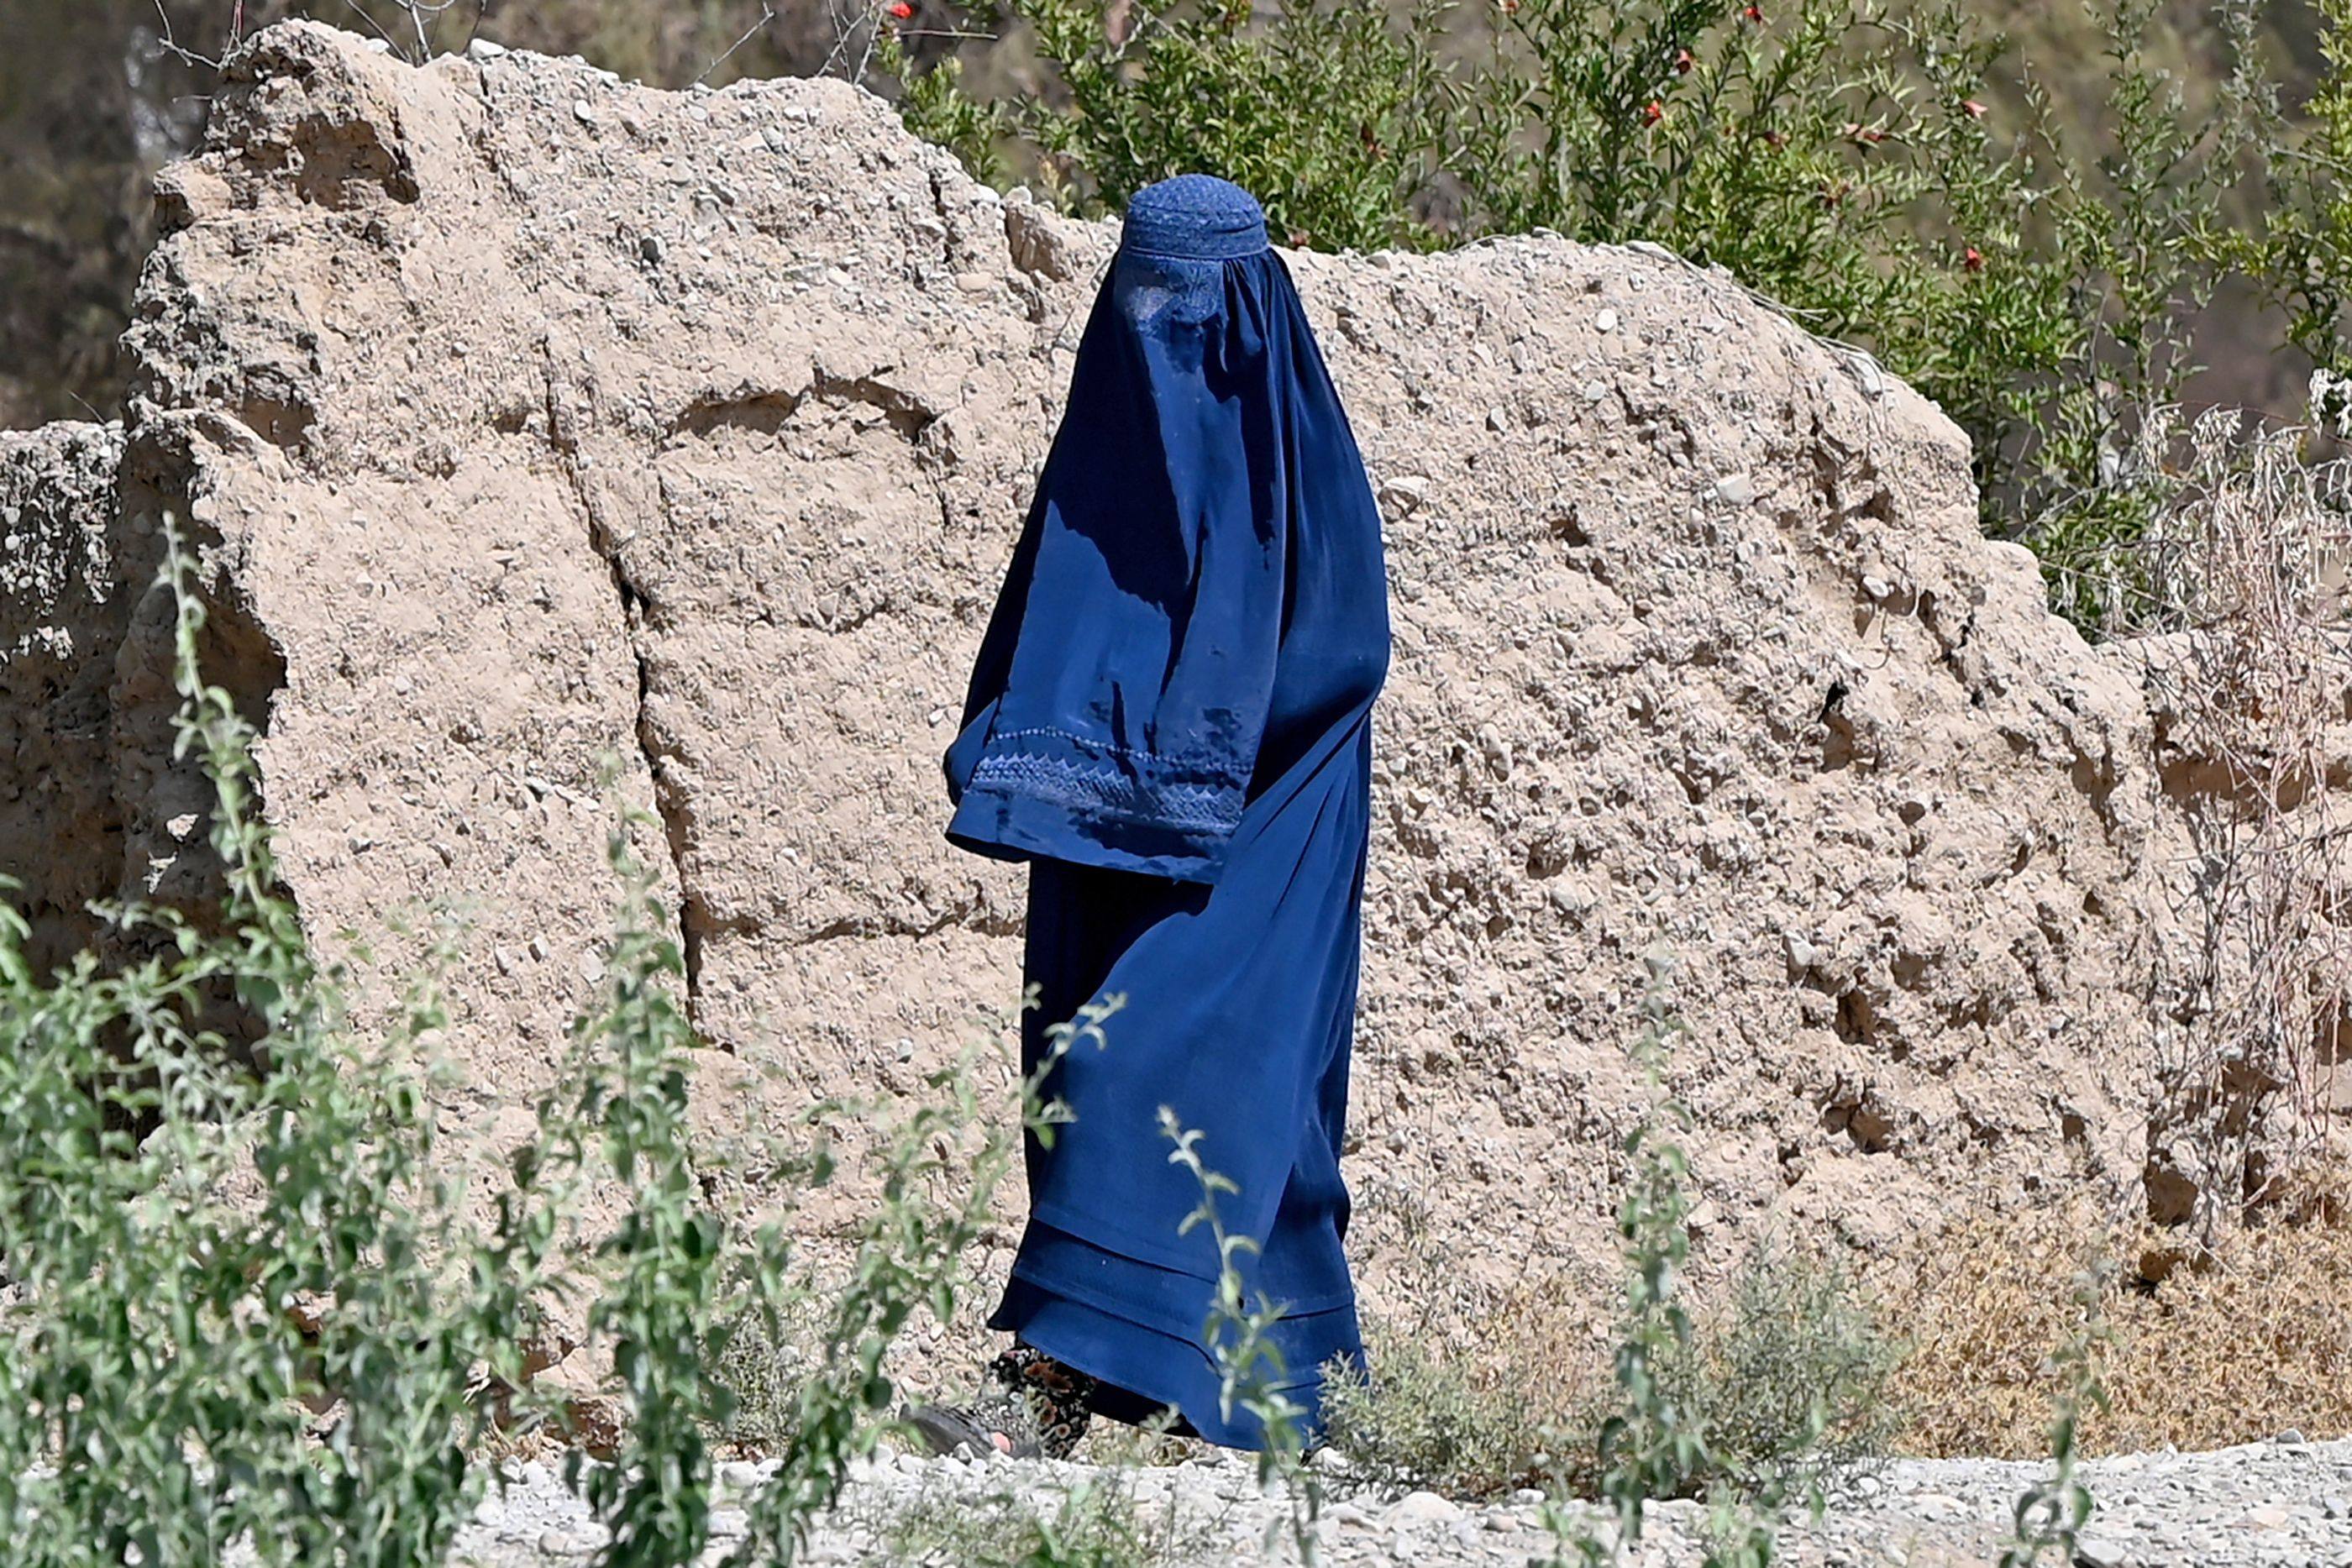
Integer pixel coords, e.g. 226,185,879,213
0,524,550,1568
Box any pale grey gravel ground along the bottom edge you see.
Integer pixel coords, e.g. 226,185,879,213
459,1434,2352,1568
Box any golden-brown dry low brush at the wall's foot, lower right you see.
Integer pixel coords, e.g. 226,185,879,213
1875,1168,2352,1457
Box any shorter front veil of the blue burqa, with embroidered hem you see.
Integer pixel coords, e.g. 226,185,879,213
946,249,1287,882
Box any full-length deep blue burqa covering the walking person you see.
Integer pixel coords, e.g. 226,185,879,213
946,174,1388,1448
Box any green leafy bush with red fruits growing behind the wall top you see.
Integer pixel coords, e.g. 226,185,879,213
885,0,2352,627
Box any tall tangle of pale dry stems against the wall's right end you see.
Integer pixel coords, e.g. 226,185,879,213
2114,412,2352,1239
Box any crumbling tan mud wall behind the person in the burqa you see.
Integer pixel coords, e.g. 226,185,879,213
0,24,2182,1335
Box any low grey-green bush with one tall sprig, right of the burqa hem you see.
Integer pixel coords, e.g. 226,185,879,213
1326,954,1900,1565
